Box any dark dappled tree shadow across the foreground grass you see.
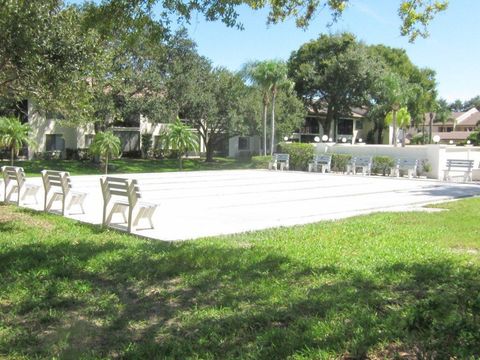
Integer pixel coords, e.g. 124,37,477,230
0,213,480,359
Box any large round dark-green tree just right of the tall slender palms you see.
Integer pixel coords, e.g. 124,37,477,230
289,33,378,137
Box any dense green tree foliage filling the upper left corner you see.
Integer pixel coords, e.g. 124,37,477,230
0,0,98,116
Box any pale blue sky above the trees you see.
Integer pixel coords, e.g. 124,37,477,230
179,0,480,101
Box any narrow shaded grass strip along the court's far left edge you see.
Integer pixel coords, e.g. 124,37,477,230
0,158,251,176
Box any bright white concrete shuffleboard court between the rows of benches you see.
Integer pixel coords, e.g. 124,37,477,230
16,170,480,240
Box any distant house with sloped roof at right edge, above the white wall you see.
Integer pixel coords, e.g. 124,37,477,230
417,108,480,143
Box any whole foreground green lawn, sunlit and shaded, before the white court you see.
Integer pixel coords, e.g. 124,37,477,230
0,198,480,359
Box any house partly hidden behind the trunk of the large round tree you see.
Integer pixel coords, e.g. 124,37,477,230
292,108,372,143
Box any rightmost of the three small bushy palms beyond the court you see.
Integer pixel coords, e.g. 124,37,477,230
165,117,198,170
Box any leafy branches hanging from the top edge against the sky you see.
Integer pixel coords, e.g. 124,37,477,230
99,0,448,41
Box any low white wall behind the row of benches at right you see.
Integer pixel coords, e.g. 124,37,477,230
314,143,480,179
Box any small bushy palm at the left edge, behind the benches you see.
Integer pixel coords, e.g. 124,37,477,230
0,117,34,166
